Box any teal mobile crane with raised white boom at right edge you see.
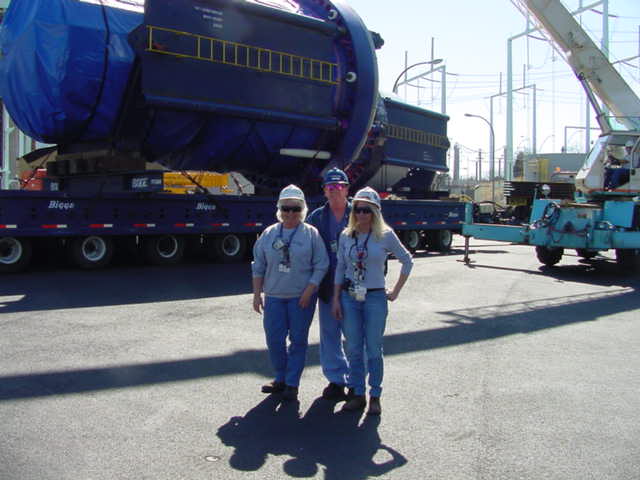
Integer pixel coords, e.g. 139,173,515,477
462,0,640,272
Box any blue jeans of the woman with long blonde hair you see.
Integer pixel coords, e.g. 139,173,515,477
341,290,389,397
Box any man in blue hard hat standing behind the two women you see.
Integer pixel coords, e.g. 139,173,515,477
307,168,351,400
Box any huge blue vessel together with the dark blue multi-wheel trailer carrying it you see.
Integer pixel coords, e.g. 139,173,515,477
0,0,464,272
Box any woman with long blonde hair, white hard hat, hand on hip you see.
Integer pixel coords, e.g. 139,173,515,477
332,187,413,415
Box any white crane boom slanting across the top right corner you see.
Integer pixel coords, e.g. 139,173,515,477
512,0,640,132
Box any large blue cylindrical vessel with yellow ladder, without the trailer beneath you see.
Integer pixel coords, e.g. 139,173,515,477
0,0,377,189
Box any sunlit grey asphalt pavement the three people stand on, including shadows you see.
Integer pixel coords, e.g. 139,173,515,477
0,236,640,480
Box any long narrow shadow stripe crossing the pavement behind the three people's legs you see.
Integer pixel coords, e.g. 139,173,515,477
0,288,638,401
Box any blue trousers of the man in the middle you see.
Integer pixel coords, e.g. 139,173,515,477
318,300,349,385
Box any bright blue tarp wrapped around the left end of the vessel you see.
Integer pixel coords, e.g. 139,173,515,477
0,0,143,143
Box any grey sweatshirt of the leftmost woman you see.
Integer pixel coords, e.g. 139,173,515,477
251,223,329,298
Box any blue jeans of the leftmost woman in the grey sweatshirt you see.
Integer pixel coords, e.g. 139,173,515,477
263,297,316,387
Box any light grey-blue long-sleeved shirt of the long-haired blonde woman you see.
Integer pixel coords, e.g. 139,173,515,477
335,229,413,288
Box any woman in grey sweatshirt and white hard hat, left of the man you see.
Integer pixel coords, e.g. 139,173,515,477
251,185,329,400
